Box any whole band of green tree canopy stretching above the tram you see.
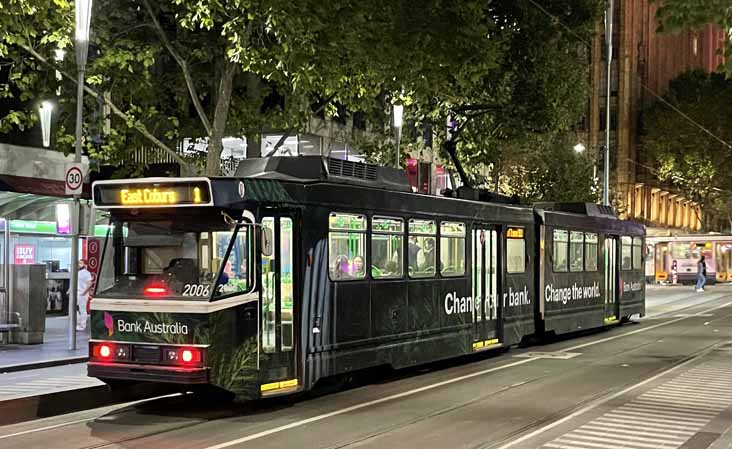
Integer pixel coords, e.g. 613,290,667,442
0,0,601,186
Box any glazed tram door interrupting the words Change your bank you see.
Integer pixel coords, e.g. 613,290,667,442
471,227,499,347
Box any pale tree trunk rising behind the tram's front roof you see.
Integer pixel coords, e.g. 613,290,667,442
206,58,238,176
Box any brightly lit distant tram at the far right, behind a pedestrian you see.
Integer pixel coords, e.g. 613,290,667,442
646,234,732,284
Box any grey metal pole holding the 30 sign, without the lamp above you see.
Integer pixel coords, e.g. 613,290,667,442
69,69,85,351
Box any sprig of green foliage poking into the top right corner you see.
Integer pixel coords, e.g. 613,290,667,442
654,0,732,76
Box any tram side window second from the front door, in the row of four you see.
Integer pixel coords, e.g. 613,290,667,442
371,217,404,279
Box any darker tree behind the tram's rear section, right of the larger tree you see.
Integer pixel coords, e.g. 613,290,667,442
358,0,602,200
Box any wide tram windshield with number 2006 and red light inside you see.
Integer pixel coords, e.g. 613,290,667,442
96,217,253,300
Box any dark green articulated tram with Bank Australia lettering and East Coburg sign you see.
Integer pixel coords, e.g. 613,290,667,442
88,157,645,398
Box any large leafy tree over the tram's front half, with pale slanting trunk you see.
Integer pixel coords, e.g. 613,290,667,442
0,0,516,175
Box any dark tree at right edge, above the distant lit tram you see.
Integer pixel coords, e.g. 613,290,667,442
642,70,732,230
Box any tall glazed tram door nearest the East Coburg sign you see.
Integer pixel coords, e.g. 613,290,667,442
260,215,298,381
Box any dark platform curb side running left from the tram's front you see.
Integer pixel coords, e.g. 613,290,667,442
0,384,180,426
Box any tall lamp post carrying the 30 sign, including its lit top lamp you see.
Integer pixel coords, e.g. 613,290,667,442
69,0,92,351
